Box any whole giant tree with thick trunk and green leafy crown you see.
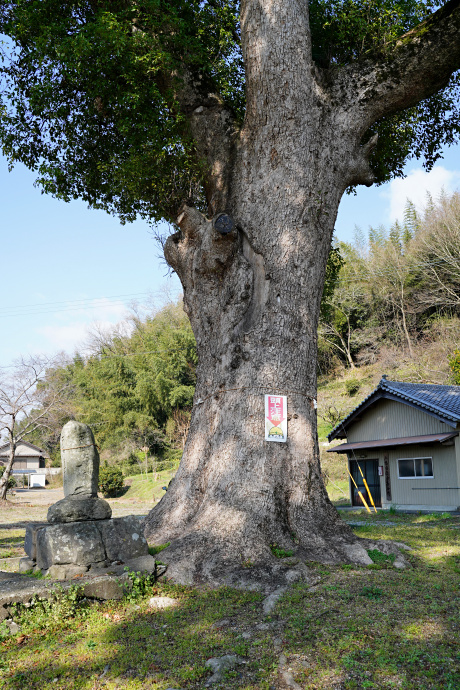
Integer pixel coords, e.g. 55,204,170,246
0,0,460,581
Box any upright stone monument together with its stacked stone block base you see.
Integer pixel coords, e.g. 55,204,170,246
19,421,156,580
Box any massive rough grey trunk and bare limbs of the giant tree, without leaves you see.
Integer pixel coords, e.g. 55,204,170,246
145,0,460,582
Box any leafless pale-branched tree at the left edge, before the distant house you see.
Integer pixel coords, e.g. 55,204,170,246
0,357,69,501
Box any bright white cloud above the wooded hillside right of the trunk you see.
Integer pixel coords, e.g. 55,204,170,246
382,165,460,222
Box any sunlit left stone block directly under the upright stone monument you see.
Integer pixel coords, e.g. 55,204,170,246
37,522,105,570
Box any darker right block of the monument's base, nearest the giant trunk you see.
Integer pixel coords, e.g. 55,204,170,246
98,515,149,563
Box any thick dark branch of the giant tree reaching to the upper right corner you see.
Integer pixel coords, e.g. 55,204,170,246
334,0,460,135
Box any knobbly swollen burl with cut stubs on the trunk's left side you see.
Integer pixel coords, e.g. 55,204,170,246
164,206,258,366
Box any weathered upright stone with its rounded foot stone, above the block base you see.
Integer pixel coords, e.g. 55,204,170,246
47,420,112,523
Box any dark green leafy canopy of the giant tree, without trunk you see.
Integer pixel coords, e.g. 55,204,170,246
0,0,460,222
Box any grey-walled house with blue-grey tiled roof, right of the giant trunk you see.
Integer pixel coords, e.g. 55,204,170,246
328,376,460,511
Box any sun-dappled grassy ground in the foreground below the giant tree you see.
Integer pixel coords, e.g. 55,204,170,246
0,512,460,690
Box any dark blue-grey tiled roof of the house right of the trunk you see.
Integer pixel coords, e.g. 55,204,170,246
328,376,460,441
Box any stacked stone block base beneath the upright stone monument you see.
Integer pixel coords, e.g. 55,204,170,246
20,515,155,580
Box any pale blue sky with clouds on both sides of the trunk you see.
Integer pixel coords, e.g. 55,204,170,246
0,146,460,366
